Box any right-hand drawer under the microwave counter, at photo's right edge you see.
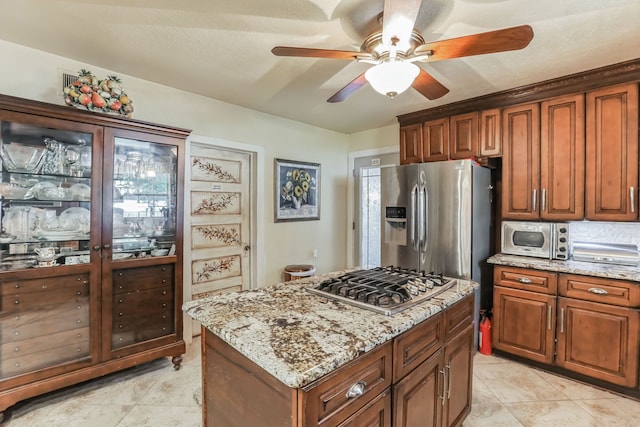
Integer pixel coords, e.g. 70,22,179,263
558,274,640,307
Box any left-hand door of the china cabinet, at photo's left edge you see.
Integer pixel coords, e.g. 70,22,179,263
0,112,101,380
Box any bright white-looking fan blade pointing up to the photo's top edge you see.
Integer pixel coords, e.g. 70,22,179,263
382,0,422,51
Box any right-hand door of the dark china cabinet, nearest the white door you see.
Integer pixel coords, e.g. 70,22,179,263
101,128,184,358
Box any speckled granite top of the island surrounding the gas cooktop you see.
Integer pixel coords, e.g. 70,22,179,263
182,272,478,388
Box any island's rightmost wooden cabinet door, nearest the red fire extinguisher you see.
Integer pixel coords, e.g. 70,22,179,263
442,325,474,427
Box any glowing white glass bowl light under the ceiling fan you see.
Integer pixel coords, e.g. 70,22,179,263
364,61,420,98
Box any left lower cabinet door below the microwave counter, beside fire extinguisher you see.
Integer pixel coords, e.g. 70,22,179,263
492,286,556,364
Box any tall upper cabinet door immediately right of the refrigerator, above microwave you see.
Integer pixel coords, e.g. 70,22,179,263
502,104,540,219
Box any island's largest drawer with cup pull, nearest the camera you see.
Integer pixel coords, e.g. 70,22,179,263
303,342,392,426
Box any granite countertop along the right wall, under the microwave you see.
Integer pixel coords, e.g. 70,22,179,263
487,254,640,282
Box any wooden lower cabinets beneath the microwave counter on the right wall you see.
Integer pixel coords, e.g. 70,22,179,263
493,266,640,393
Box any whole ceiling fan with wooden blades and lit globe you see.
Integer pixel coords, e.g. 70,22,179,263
271,0,533,102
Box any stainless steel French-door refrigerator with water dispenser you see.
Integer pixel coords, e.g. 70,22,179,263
380,160,492,342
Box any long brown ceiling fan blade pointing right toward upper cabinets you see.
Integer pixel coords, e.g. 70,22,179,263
414,25,533,62
